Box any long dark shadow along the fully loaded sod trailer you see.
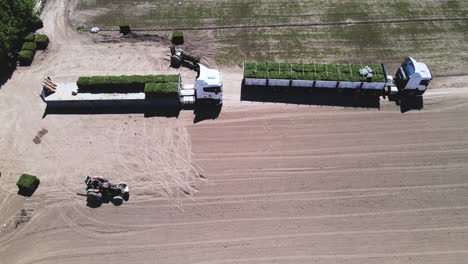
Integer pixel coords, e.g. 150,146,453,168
241,89,380,109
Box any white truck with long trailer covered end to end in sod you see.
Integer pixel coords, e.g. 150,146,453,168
241,57,432,108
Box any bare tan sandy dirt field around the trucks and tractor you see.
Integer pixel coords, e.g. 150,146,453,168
0,0,468,264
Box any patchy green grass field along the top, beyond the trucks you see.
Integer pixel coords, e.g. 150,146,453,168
79,0,468,74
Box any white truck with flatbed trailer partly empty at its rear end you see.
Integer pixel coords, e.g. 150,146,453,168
41,65,223,111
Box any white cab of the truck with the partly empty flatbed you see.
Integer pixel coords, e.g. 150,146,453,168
195,64,223,105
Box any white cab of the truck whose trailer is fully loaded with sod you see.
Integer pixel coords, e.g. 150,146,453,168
395,57,432,96
